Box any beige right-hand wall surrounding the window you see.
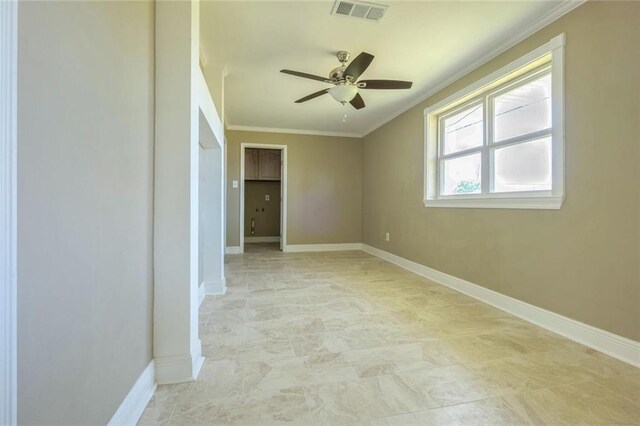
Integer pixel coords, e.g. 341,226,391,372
363,2,640,340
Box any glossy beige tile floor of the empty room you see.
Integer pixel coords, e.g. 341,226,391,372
140,245,640,425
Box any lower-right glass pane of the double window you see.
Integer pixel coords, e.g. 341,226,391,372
494,138,551,192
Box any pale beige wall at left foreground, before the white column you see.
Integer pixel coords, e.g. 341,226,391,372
18,2,154,425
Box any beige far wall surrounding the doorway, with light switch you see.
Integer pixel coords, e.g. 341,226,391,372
226,130,362,246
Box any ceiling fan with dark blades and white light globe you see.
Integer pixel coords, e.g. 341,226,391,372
280,50,413,109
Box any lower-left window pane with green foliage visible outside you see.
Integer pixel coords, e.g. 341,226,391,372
442,153,480,195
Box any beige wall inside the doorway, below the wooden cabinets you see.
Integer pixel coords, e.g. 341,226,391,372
244,180,280,237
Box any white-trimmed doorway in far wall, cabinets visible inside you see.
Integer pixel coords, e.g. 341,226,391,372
240,143,287,253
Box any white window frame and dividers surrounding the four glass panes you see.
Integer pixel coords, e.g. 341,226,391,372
424,34,565,210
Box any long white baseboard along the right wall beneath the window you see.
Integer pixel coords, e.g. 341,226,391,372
362,244,640,367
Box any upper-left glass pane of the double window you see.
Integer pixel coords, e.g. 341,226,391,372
442,104,484,155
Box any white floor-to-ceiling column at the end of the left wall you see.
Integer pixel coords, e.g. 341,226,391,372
153,1,204,383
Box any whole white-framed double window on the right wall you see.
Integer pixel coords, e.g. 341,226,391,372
424,34,564,209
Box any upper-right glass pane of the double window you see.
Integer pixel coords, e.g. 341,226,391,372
494,74,551,141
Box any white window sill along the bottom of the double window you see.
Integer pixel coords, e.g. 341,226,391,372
424,197,564,210
